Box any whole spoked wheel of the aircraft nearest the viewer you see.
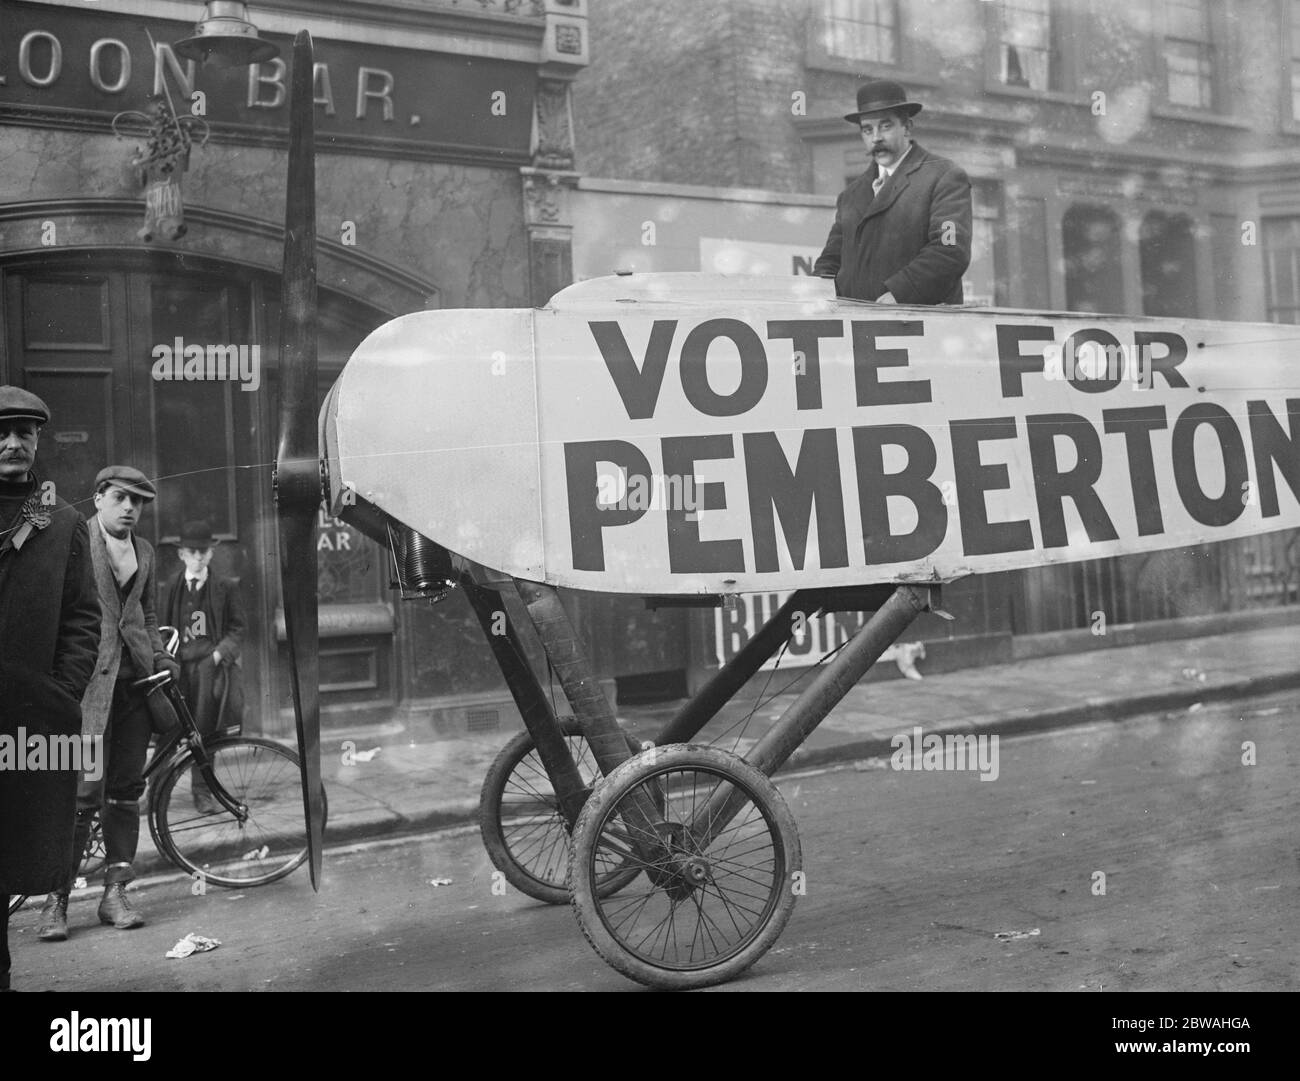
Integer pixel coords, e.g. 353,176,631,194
569,744,801,989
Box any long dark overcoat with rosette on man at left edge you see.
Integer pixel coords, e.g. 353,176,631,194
0,500,100,894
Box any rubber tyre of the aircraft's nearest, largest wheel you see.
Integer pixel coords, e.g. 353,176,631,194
569,743,803,990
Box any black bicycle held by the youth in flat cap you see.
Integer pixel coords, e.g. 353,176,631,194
9,626,324,915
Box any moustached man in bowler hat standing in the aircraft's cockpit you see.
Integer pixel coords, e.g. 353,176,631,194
813,79,971,304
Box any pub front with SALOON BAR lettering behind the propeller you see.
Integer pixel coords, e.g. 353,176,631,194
0,0,588,734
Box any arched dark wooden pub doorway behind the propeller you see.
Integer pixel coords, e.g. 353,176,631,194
0,252,400,735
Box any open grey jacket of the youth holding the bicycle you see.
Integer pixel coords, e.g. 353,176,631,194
82,515,165,735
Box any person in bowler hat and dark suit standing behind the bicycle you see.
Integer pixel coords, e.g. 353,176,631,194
160,521,247,812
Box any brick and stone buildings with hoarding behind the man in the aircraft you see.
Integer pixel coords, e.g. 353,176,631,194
575,0,1300,686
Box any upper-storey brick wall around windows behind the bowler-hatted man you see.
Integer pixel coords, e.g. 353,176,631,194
573,0,1296,191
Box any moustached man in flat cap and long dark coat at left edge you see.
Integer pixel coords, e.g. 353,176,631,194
0,386,100,989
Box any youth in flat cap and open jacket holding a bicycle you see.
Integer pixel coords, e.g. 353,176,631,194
36,465,179,942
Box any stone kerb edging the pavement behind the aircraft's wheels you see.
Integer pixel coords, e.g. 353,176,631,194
53,669,1300,893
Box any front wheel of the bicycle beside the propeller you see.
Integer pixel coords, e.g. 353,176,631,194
150,735,324,889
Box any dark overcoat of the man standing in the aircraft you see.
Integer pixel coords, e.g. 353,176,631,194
813,143,971,304
